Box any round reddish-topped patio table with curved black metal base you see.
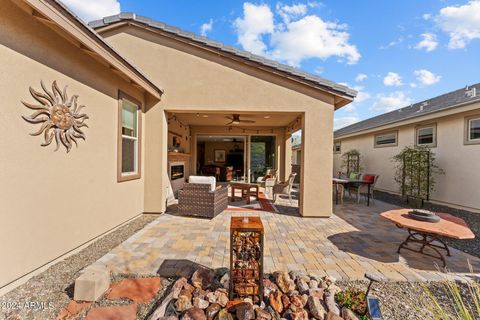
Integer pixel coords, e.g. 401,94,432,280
380,209,475,267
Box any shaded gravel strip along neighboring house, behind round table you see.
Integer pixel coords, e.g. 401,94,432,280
375,191,480,258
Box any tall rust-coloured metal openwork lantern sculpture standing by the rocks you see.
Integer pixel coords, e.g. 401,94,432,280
229,217,264,303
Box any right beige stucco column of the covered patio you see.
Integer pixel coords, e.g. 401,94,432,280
299,107,333,217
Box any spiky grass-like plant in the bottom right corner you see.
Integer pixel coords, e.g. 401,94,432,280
423,280,480,320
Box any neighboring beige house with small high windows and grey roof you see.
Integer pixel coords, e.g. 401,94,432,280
333,84,480,212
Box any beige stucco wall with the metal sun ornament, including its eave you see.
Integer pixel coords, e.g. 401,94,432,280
0,1,150,287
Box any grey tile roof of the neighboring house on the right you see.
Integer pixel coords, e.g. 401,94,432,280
334,83,480,138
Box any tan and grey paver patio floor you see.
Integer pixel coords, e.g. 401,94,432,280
91,201,480,281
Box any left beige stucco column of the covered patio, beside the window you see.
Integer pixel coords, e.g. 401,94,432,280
143,105,169,213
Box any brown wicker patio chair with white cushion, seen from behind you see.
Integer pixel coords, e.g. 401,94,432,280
178,176,228,219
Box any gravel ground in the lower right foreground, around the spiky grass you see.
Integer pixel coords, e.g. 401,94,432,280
337,281,480,320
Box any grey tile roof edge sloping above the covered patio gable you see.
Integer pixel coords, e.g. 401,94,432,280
89,13,357,98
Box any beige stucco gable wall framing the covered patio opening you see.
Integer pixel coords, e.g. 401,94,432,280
99,26,334,216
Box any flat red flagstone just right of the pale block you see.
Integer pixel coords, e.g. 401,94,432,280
107,278,162,303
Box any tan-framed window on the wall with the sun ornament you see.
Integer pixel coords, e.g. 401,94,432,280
117,92,142,181
